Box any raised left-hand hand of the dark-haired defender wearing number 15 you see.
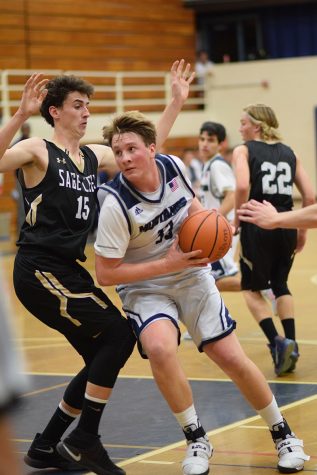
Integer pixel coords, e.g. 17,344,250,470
19,73,48,117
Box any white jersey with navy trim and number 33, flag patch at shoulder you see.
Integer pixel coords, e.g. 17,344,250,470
95,155,201,287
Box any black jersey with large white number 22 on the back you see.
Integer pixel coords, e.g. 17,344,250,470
245,140,296,211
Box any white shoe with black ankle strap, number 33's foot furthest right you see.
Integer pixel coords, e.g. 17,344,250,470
271,419,310,473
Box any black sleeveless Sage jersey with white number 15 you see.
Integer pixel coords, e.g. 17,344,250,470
17,140,98,261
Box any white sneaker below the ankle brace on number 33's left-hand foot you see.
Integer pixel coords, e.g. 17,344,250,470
182,436,213,475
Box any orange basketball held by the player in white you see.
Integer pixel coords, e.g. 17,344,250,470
179,209,232,262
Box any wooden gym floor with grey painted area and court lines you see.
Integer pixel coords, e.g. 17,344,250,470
0,235,317,475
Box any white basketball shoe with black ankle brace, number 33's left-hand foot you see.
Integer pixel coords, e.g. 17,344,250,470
182,425,213,475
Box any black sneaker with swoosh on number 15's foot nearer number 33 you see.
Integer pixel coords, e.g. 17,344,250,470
56,428,126,475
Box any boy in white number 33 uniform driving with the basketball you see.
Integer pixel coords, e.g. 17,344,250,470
95,111,309,475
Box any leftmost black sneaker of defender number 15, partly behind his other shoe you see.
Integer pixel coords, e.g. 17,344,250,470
24,434,84,471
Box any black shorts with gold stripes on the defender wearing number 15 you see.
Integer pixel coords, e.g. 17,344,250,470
13,249,131,355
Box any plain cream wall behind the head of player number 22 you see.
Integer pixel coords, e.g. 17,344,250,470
209,57,317,195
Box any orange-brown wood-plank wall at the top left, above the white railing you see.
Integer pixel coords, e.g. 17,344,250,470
0,0,195,71
